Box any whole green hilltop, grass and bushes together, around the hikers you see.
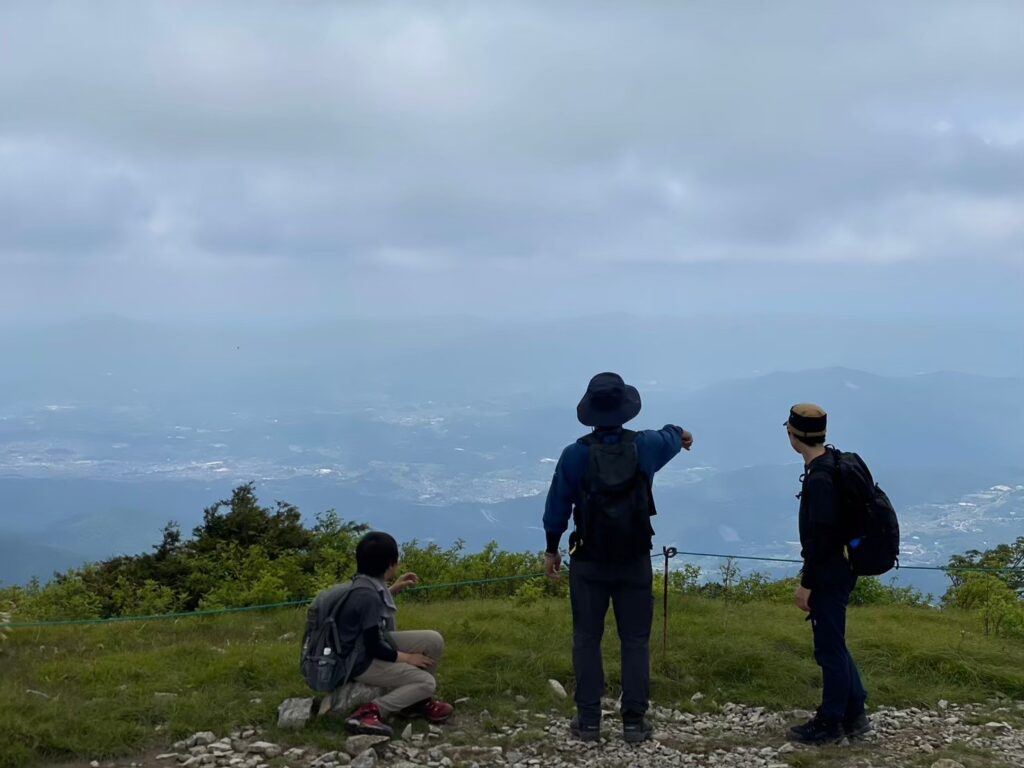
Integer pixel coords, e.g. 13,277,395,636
0,484,1024,768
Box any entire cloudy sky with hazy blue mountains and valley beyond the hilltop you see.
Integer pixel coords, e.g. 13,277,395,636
0,0,1024,593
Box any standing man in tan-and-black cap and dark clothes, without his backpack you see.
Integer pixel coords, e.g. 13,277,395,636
785,403,871,744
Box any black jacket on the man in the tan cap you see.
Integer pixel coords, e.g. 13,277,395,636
800,453,853,592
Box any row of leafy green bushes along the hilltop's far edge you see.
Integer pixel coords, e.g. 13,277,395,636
0,483,1024,635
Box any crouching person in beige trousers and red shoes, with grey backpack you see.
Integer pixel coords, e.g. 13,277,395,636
303,531,453,735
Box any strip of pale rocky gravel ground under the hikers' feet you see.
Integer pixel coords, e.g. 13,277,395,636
66,700,1024,768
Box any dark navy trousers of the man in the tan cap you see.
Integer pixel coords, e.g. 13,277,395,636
810,578,867,720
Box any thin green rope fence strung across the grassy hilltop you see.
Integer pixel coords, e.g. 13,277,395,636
2,547,1024,630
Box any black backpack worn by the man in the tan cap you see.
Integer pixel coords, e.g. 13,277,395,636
828,445,899,575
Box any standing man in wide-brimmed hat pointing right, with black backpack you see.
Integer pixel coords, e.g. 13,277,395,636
544,373,693,742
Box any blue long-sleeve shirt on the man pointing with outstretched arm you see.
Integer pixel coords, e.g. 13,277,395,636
544,424,683,552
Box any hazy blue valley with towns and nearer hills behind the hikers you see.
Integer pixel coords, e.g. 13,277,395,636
0,354,1024,583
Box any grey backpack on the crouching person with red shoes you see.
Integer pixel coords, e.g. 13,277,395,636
299,582,373,693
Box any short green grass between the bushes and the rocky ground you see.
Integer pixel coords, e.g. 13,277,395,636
0,597,1024,768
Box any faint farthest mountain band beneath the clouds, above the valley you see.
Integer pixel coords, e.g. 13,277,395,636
0,313,1024,411
